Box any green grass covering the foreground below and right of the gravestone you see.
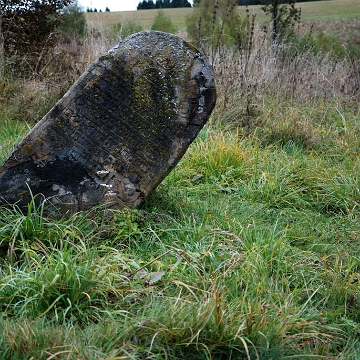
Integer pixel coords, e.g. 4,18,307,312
0,122,360,359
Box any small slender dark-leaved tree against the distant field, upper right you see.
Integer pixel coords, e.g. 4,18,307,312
261,0,301,41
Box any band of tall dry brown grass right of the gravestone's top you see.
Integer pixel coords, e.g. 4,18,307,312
214,26,360,103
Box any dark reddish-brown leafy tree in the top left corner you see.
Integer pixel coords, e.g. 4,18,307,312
0,0,72,72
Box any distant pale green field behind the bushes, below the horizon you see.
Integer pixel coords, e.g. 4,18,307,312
87,0,360,30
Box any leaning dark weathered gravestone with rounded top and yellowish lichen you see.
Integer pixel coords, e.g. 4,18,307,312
0,31,216,213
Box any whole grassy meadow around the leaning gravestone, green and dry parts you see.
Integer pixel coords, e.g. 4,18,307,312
0,0,360,360
